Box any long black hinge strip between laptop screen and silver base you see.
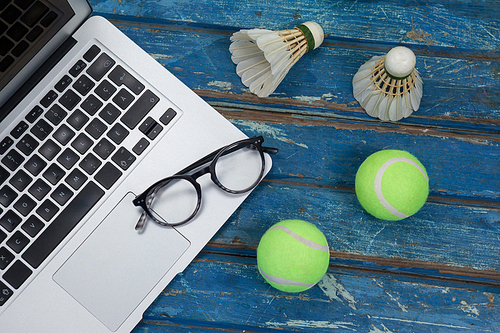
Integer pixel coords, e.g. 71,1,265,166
0,36,77,121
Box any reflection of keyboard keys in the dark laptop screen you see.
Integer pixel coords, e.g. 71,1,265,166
0,0,59,73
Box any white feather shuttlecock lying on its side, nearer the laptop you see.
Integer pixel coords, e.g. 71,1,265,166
229,22,324,97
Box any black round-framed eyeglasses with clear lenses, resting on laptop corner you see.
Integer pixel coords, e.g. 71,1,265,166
132,136,278,231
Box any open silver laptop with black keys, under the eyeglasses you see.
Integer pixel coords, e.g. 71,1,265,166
0,0,271,333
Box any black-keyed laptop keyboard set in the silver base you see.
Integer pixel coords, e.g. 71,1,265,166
0,44,177,306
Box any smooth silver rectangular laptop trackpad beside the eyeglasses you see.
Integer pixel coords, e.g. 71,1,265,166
54,193,190,331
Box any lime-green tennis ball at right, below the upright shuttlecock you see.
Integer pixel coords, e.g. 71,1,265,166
356,150,429,221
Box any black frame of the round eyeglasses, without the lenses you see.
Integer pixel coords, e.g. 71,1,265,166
132,136,278,230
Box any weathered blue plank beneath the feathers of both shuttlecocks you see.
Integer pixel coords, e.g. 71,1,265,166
93,20,500,128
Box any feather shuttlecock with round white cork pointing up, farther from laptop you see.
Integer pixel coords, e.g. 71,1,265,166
352,46,423,121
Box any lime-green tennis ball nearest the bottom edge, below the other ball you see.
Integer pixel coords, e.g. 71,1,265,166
257,220,330,292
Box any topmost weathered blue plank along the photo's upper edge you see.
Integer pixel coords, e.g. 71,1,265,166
91,0,500,54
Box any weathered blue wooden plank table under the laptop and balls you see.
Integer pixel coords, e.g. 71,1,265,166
91,0,500,333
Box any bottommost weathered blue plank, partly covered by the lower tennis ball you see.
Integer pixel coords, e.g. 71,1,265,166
130,253,500,332
